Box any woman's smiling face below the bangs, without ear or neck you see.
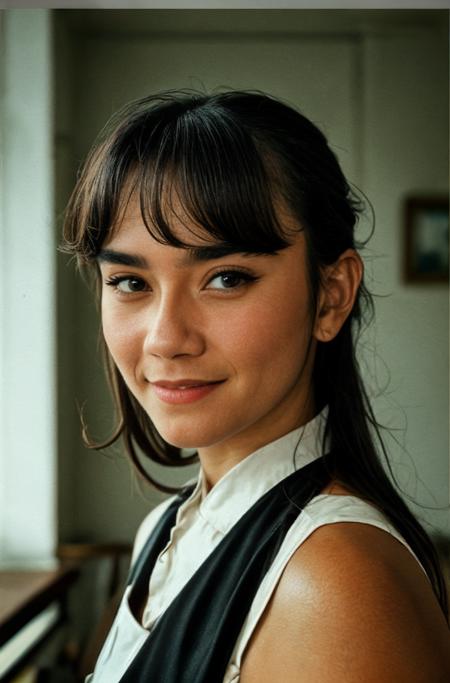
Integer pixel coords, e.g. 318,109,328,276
98,201,315,459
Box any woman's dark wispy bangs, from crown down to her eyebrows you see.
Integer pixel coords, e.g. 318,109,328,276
66,101,300,260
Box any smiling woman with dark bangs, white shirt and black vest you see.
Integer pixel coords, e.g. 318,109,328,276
65,92,450,683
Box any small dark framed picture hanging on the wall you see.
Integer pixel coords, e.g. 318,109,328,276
405,196,449,283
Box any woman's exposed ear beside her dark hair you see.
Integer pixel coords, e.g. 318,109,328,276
314,249,364,342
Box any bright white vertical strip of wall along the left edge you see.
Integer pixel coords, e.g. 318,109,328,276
0,10,57,567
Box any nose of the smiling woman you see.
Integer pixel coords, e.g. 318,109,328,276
144,296,205,359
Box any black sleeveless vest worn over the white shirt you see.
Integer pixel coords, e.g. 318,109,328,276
120,456,330,683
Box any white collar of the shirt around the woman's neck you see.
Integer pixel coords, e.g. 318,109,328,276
182,407,328,534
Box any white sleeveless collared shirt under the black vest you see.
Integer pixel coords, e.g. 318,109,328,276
86,409,424,683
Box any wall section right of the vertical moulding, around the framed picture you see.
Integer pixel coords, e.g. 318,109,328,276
364,30,449,531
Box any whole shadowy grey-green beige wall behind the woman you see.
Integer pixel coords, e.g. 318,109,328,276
56,10,448,539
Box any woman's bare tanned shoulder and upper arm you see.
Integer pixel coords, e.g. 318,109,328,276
241,522,450,683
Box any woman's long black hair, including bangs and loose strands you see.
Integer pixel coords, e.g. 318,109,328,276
64,91,447,618
